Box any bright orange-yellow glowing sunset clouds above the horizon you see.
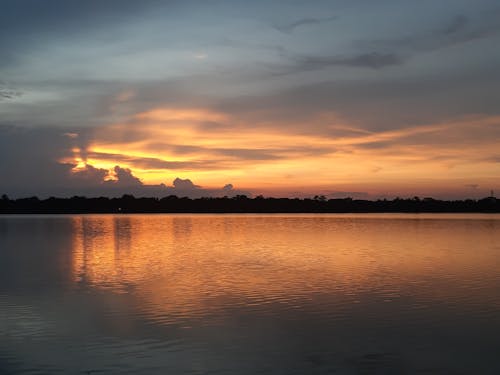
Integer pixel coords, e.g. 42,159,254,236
61,108,500,198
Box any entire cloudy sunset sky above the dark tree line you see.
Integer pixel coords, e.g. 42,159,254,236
0,0,500,199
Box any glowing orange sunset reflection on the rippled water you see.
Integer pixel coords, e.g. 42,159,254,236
72,215,500,320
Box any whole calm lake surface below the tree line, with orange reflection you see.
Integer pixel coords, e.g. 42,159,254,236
0,214,500,374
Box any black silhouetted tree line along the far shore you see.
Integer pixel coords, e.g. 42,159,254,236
0,194,500,214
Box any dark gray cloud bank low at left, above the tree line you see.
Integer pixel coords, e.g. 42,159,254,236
0,126,251,198
